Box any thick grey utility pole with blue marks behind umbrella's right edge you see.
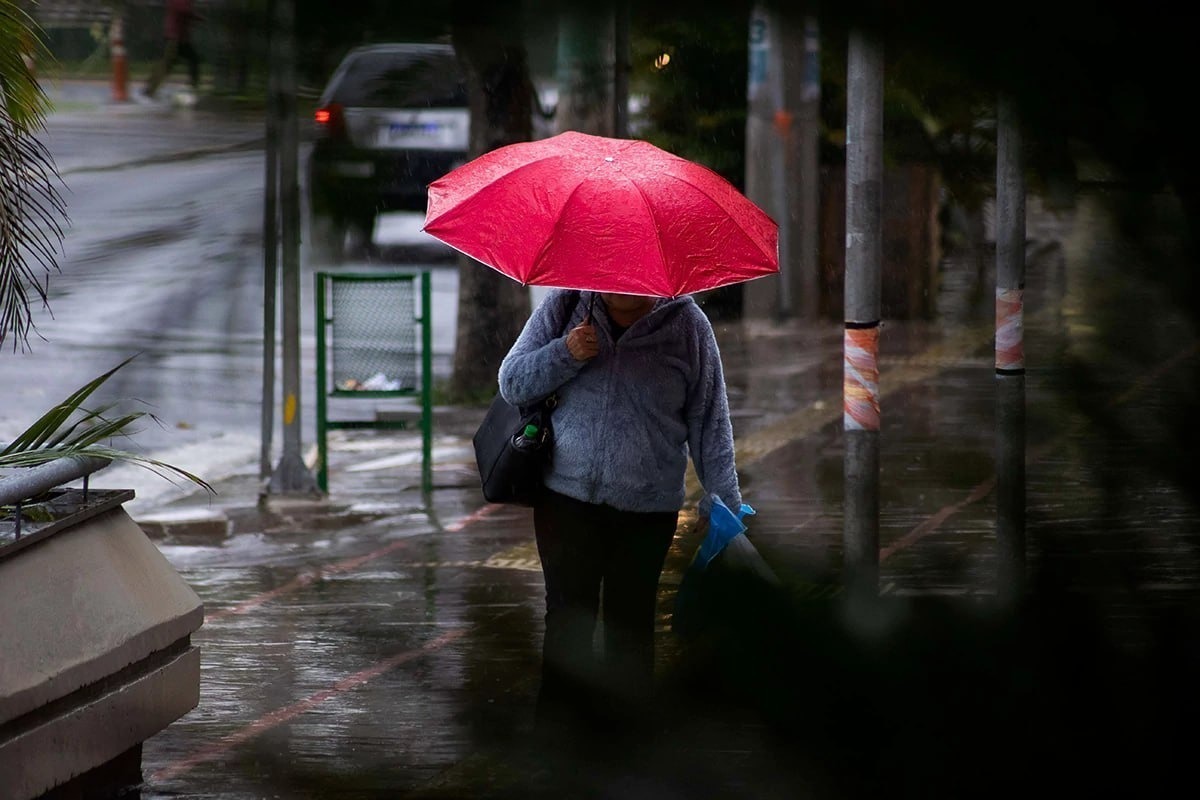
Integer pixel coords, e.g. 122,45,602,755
743,2,821,319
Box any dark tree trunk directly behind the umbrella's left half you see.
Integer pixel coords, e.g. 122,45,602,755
449,0,534,403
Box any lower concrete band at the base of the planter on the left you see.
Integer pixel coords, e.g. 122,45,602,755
0,646,200,800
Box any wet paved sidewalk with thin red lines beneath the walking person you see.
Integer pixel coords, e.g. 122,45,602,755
129,194,1200,800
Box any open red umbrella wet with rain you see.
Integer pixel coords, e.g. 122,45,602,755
424,132,779,297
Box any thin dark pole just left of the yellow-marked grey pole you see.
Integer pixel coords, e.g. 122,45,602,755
258,0,280,486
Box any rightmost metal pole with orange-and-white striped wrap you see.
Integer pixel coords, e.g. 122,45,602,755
996,96,1025,602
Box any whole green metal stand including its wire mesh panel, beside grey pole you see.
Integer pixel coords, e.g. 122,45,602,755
316,270,433,492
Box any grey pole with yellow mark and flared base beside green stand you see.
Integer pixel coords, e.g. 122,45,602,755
268,0,318,494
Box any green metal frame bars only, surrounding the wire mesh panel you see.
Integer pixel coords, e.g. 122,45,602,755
316,270,433,493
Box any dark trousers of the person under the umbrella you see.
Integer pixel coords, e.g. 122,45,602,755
534,492,678,734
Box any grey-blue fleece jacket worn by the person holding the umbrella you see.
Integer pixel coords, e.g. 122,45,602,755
499,289,742,516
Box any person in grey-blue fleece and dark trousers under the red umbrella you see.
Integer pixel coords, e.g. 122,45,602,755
499,289,742,746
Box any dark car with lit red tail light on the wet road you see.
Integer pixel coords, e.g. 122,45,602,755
307,43,469,258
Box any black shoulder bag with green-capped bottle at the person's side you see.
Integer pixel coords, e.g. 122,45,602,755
473,295,578,506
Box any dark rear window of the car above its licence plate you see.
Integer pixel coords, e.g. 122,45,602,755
331,52,467,108
